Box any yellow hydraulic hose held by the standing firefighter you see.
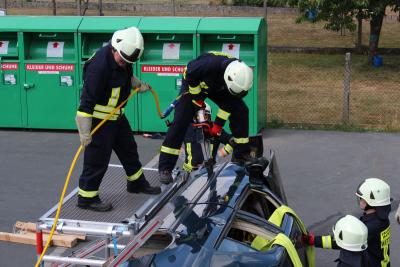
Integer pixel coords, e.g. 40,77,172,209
35,88,162,267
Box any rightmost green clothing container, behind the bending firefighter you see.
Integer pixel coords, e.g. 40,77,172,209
197,17,267,135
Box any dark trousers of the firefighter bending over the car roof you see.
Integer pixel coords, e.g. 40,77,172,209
158,90,250,171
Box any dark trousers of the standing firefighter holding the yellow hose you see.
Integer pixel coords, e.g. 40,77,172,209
79,115,142,197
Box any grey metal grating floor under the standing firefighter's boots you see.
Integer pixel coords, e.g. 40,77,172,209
41,169,160,223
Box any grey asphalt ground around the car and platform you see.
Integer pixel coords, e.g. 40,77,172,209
0,130,400,266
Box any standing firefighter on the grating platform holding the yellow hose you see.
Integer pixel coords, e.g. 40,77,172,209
76,27,161,211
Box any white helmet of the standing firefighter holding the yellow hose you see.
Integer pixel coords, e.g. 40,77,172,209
111,27,144,63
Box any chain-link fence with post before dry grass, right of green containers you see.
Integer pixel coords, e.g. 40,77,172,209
267,53,400,130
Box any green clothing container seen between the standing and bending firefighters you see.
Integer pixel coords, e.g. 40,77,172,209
138,17,200,132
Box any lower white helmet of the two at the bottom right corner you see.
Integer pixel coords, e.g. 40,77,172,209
333,215,368,251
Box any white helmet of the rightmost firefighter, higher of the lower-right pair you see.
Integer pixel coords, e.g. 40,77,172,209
356,178,390,207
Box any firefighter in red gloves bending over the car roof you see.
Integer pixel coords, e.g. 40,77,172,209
158,52,253,184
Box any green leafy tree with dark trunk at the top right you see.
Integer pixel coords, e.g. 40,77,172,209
283,0,400,57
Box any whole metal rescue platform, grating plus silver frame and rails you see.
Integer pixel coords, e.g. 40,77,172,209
37,165,183,266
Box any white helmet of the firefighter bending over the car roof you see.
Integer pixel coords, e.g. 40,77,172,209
224,60,253,95
